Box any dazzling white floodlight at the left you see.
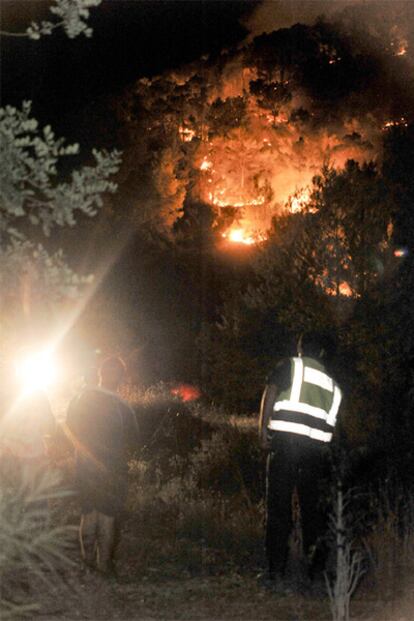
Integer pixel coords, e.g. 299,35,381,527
16,351,57,393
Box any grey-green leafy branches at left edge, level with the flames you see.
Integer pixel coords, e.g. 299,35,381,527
0,102,120,240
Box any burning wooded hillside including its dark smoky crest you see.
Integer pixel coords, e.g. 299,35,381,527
120,16,404,245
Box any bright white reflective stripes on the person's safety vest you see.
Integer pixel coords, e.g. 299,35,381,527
268,358,342,442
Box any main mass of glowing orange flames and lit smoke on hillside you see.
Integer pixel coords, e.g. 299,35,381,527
188,65,382,245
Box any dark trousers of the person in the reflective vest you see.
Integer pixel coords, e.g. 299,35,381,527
265,433,327,575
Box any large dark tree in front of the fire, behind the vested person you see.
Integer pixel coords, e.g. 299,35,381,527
204,161,394,426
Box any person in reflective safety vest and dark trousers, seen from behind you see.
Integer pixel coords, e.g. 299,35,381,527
259,333,342,588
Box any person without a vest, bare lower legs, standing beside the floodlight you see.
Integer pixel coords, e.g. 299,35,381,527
65,357,138,575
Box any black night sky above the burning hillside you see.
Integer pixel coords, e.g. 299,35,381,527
1,0,258,142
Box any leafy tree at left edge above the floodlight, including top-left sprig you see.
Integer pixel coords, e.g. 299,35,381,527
0,0,121,342
